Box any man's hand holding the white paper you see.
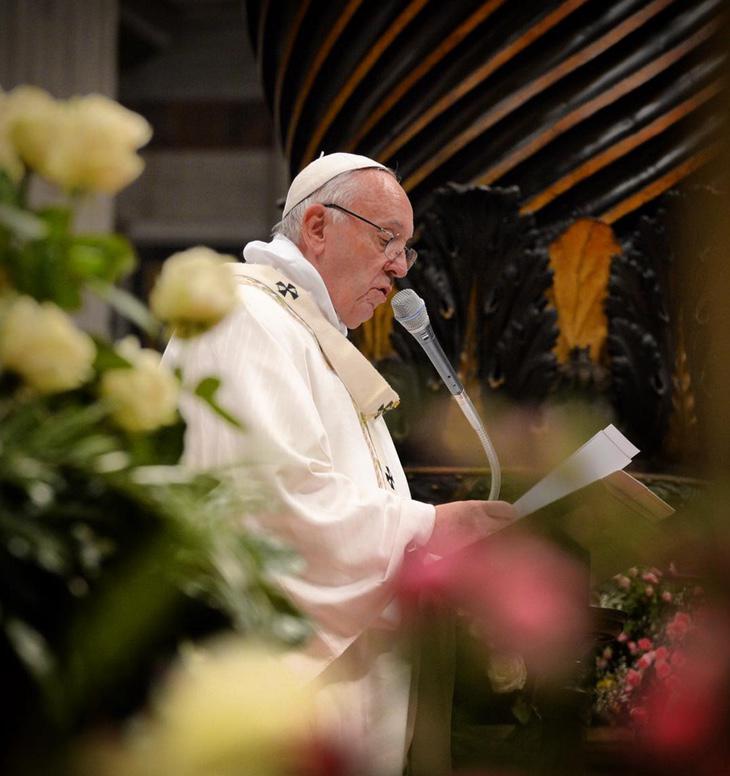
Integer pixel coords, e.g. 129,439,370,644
428,501,517,554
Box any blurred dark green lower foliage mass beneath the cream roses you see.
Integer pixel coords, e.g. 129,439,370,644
0,384,307,725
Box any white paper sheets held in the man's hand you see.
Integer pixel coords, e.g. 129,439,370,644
513,425,639,517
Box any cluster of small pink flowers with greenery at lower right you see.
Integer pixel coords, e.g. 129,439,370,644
594,567,704,725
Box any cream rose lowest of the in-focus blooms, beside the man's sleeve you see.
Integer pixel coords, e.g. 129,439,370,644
100,337,180,431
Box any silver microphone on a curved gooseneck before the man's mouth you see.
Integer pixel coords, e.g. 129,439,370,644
390,288,502,501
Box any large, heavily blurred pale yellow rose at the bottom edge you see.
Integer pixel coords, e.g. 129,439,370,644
147,639,314,776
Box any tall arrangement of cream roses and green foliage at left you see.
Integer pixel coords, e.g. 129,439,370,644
0,86,307,749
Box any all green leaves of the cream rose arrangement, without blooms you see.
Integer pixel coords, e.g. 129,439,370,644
0,142,308,756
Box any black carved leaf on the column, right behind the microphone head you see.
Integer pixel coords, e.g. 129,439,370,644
393,184,557,401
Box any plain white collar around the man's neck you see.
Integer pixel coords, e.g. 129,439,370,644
243,234,347,336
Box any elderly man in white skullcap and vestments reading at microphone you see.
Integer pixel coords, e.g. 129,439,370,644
171,153,510,774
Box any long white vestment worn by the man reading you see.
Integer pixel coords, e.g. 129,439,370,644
166,236,435,776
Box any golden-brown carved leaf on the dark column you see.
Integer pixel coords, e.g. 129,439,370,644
548,218,621,364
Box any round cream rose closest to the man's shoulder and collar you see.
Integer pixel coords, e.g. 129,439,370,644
150,246,236,337
